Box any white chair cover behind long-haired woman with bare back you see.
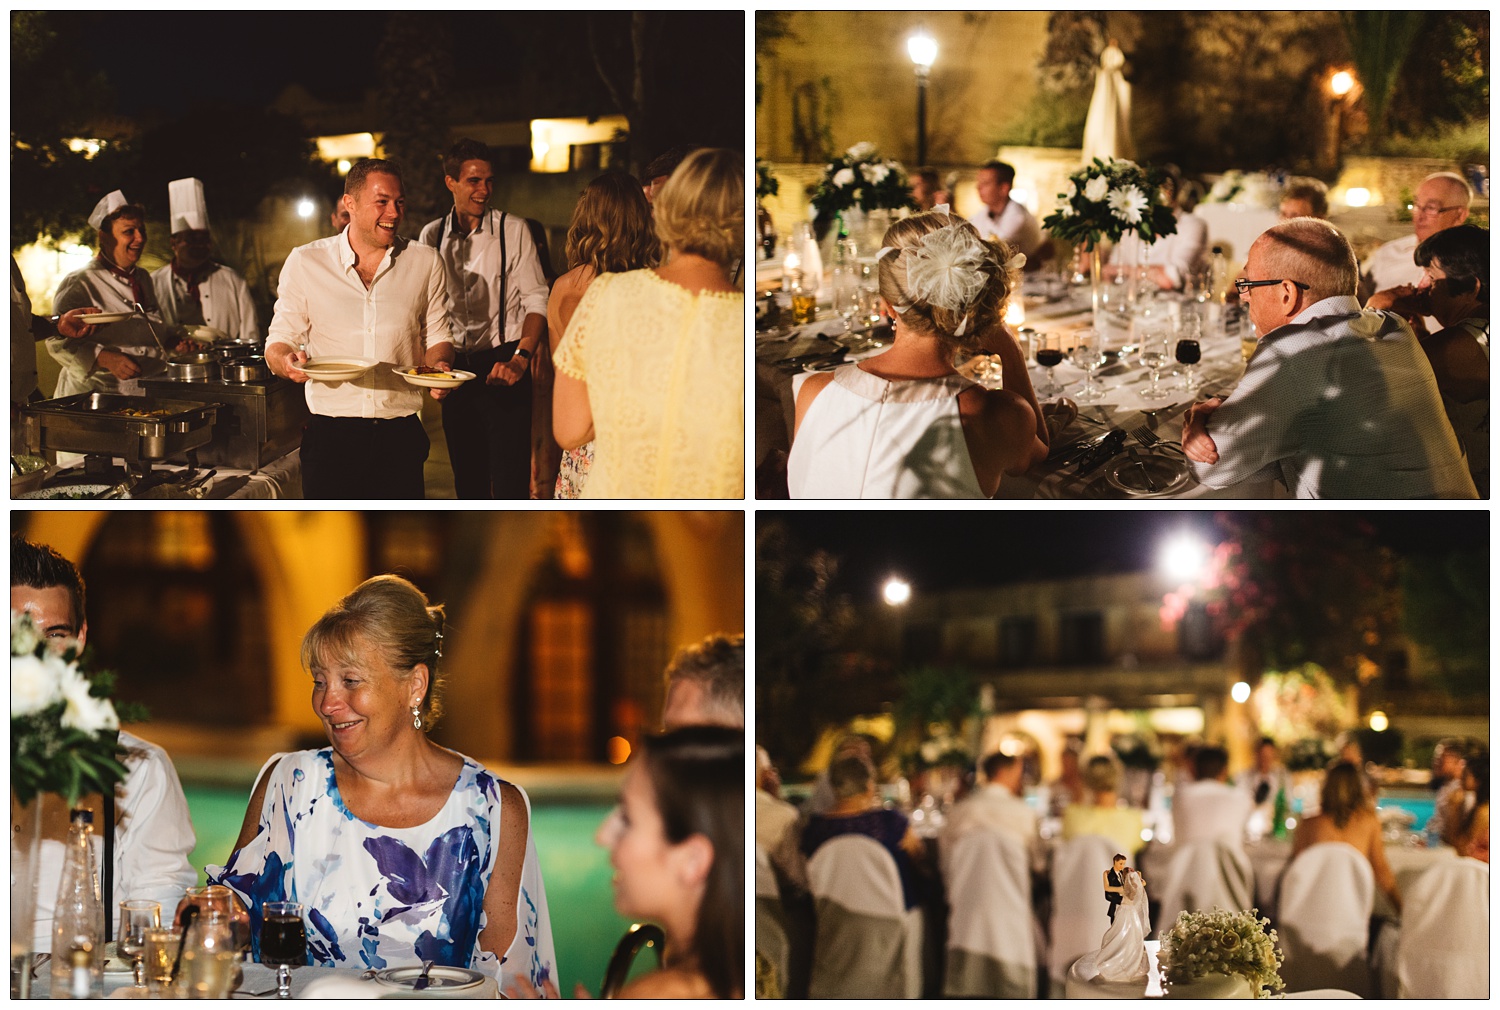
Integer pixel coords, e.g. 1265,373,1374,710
1277,842,1376,996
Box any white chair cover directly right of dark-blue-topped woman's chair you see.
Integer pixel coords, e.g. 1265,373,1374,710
944,830,1037,999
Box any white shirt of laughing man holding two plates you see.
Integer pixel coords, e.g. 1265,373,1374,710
266,228,452,419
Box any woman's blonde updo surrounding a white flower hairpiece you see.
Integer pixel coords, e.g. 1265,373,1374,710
881,210,1016,351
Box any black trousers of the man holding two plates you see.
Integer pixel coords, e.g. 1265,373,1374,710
302,414,431,500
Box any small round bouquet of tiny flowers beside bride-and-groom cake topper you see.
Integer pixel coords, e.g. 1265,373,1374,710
1158,908,1286,999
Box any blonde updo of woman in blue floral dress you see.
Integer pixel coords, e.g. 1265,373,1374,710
302,575,446,729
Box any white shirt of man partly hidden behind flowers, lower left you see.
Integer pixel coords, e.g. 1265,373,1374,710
35,729,200,951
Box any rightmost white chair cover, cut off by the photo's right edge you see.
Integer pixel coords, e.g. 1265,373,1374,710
1397,857,1490,999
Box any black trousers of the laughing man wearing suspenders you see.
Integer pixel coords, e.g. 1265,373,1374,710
443,344,531,498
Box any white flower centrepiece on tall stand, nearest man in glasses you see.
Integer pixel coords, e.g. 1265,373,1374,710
1041,158,1178,249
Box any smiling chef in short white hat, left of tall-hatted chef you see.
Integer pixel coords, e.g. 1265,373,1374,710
47,189,176,396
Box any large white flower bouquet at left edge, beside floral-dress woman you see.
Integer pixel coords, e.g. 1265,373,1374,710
11,611,144,806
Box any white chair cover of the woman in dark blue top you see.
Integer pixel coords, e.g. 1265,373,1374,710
807,834,923,999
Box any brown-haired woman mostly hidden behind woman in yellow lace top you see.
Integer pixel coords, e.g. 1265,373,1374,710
548,171,662,498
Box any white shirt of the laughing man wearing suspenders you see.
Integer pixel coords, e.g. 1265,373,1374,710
419,210,548,351
